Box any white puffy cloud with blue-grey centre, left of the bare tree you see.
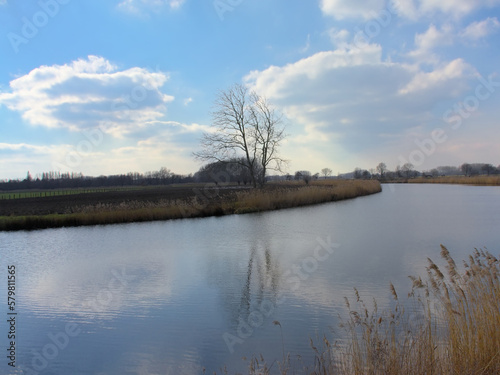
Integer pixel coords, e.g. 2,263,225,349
0,56,174,136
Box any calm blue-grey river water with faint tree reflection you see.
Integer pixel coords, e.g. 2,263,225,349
0,184,500,375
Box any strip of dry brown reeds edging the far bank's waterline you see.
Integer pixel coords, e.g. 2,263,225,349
0,180,381,231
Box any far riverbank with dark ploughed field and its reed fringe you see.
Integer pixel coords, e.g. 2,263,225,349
0,180,381,231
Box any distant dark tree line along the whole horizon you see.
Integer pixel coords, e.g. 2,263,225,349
0,158,500,191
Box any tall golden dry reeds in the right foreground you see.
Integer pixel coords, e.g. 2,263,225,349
236,246,500,375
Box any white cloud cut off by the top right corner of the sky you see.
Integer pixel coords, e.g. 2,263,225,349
392,0,500,20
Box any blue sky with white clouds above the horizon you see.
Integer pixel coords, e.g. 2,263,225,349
0,0,500,179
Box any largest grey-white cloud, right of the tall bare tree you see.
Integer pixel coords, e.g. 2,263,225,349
245,44,475,169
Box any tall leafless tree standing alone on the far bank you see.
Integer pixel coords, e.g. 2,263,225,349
194,84,286,187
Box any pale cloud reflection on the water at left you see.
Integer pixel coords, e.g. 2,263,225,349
24,241,176,319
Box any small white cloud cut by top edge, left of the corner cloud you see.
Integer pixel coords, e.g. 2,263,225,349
321,0,385,20
